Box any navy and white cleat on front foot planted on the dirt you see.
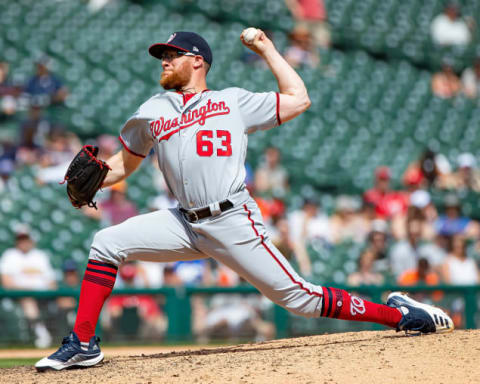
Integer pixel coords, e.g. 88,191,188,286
35,331,104,372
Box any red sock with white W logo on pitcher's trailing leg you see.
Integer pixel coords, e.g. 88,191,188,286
320,287,402,328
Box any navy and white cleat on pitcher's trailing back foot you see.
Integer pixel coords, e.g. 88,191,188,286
387,292,454,333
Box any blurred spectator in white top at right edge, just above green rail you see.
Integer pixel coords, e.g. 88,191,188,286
442,234,480,285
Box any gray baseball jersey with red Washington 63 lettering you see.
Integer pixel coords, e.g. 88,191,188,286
120,88,278,209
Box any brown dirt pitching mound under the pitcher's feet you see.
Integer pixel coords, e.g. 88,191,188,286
0,330,480,384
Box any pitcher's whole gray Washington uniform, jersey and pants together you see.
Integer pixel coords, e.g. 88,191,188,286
90,88,323,317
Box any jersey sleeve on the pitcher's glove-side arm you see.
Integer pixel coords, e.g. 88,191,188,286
119,107,153,157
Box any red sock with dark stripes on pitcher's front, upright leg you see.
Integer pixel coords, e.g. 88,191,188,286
73,260,118,342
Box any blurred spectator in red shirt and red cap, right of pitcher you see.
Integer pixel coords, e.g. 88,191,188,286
363,166,408,219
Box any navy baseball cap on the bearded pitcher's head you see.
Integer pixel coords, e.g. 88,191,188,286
148,32,213,65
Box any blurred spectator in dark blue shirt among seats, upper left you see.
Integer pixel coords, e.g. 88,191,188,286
24,56,68,107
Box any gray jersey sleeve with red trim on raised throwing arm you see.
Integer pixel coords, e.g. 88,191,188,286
238,88,281,133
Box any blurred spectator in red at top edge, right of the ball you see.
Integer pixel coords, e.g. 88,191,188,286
285,0,330,48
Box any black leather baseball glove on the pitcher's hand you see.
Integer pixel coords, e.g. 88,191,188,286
62,145,111,209
